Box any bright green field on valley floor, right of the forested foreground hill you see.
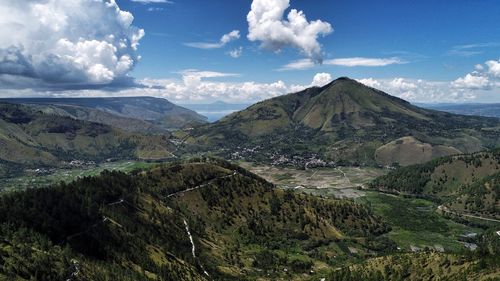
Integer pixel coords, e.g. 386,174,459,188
356,191,482,252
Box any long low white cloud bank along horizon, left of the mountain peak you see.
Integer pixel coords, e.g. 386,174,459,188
0,69,331,103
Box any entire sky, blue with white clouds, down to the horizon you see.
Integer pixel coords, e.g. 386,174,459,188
0,0,500,104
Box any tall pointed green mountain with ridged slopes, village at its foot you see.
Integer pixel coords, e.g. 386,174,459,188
186,78,500,165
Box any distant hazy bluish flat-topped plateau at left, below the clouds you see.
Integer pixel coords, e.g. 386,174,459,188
0,97,207,133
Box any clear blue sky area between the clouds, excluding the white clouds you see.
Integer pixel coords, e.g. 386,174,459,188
122,0,500,83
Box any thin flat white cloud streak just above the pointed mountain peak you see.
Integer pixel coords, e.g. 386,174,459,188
278,57,407,70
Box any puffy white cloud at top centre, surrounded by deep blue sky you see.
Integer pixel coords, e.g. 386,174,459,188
247,0,333,62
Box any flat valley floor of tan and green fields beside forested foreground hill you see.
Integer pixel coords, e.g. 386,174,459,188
240,163,492,253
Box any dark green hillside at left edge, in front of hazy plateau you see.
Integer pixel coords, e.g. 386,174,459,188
0,103,173,175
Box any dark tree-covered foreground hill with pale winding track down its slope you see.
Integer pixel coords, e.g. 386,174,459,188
0,159,394,281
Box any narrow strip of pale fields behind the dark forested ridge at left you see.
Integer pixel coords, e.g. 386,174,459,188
0,160,157,192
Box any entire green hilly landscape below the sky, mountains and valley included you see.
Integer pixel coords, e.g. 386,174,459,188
0,78,500,281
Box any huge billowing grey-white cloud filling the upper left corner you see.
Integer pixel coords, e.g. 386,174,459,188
0,0,144,87
